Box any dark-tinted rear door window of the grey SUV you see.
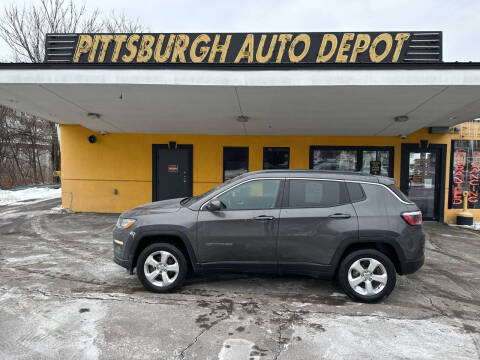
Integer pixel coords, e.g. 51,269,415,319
288,180,347,208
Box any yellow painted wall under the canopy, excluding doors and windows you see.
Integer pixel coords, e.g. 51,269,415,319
61,125,472,221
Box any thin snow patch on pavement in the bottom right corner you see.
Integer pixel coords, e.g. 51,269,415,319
285,312,476,360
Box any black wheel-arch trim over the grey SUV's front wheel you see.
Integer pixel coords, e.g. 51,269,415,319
128,225,199,274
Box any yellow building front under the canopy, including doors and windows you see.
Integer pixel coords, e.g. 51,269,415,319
61,122,480,222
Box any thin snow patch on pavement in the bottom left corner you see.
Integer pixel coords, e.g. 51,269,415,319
0,294,107,360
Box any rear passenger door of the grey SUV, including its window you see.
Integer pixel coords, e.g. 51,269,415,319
278,179,358,273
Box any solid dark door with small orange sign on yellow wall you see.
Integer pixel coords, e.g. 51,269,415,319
152,145,193,201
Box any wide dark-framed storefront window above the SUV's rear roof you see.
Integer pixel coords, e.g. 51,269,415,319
310,146,393,177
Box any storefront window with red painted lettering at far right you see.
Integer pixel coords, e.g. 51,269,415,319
449,140,480,209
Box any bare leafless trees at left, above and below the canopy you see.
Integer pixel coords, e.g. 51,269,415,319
0,0,141,183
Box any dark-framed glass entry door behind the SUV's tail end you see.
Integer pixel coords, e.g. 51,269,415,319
400,144,445,220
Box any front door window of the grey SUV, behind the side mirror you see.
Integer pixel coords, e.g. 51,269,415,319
217,179,281,210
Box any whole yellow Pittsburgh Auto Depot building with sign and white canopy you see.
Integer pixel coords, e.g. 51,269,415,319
0,32,480,222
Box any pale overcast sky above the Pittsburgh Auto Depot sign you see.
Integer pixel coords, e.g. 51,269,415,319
0,0,480,61
